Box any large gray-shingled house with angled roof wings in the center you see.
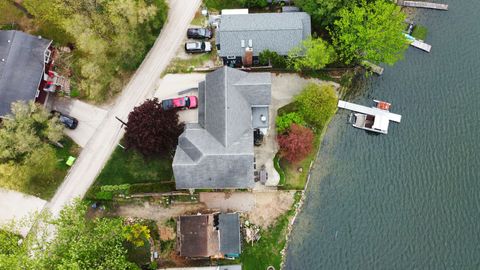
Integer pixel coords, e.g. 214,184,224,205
172,67,271,189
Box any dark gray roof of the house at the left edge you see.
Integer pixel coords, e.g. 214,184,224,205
0,30,52,116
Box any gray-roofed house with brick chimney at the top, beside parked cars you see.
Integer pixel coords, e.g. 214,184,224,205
216,12,311,67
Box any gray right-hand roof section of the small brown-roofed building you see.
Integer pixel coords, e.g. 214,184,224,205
219,213,241,254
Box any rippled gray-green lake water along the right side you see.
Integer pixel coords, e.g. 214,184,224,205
286,0,480,270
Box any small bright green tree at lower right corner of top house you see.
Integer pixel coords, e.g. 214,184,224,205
288,37,336,71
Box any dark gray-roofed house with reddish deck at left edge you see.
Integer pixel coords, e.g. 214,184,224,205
0,30,65,117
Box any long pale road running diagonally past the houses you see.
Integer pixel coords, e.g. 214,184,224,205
46,0,201,216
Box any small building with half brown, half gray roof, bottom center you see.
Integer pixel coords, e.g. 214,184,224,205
177,213,241,258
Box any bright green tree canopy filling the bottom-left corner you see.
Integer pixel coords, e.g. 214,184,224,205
0,201,138,269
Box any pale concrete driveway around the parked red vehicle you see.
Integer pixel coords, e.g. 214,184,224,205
154,73,206,123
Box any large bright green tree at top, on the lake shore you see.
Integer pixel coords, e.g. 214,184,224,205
330,0,408,65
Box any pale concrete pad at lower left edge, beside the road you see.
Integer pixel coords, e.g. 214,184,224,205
0,188,47,236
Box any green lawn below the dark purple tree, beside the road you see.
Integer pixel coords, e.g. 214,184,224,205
96,146,173,186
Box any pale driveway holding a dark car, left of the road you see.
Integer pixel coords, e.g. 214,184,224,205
53,98,108,147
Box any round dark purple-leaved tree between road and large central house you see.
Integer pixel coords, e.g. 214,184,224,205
125,98,184,156
